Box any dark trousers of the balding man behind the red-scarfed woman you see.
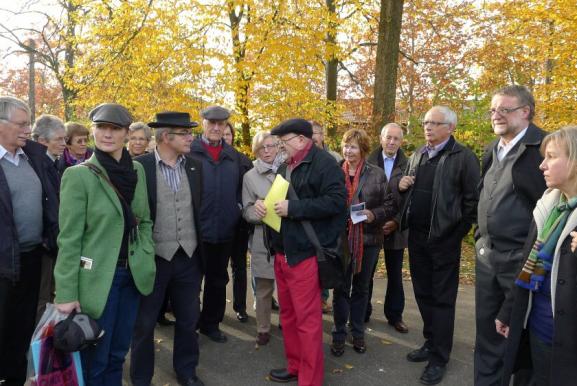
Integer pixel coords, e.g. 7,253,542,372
365,248,405,324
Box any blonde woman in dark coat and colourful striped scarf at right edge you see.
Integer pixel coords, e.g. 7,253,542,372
495,127,577,386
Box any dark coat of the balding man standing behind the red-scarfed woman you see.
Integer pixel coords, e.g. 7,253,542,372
367,147,408,249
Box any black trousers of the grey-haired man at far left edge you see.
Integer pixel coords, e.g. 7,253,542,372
0,247,45,386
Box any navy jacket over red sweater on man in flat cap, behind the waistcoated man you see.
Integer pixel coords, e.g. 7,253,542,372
190,138,245,244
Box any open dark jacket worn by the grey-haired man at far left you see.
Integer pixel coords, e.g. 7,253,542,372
0,141,59,281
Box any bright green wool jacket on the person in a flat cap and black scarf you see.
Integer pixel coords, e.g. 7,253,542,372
54,155,156,319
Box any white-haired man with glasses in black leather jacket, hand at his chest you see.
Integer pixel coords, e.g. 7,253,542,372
399,106,480,385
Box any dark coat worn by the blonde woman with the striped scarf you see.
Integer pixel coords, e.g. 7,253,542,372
497,191,577,386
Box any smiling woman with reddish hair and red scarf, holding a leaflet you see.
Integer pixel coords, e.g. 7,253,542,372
331,129,387,356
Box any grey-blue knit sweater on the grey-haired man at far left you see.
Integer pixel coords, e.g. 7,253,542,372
0,156,43,252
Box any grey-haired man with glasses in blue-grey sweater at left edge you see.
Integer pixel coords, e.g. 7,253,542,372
0,96,58,386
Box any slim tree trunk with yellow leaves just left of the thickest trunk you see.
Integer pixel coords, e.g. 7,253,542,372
325,0,338,137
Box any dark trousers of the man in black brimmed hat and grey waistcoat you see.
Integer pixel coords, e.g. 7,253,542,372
130,248,202,386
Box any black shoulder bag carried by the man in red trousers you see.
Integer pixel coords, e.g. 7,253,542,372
286,170,350,289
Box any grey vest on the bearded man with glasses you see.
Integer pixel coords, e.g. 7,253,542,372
477,143,533,251
